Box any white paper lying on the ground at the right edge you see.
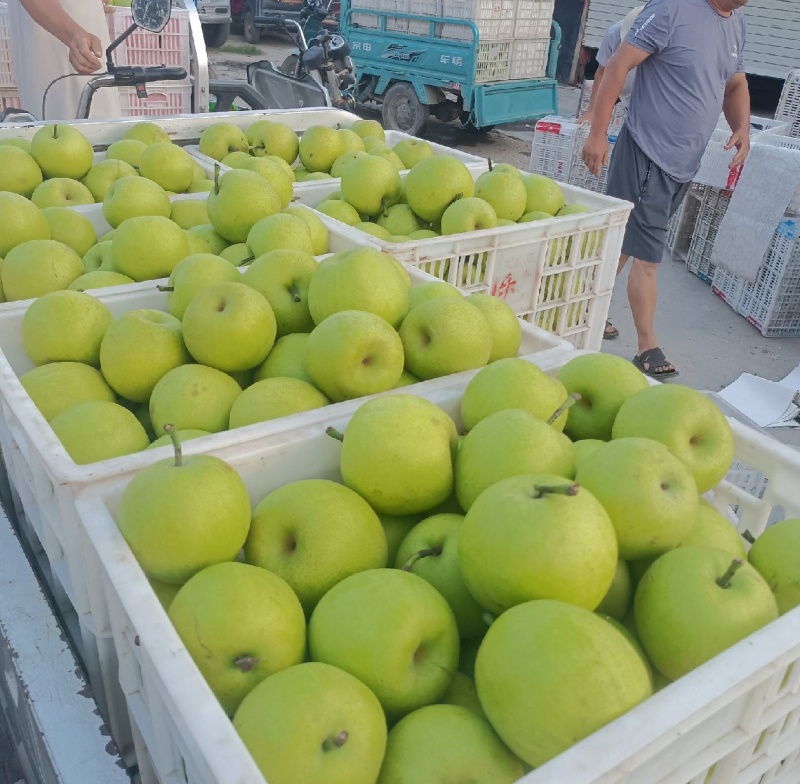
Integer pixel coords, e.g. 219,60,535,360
717,365,800,427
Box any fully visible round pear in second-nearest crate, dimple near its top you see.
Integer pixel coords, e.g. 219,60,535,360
183,283,277,373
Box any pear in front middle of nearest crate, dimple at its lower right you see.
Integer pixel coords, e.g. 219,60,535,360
308,569,458,720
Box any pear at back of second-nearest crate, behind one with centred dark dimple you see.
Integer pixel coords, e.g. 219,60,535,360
308,248,410,328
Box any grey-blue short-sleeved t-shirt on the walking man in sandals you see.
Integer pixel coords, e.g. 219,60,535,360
625,0,746,182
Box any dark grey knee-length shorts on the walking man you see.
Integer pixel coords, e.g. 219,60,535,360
606,125,691,264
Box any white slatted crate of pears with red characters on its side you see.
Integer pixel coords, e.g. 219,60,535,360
290,172,632,350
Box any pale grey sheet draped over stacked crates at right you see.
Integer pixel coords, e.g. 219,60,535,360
711,142,800,283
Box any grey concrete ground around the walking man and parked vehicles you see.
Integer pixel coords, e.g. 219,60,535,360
210,41,800,445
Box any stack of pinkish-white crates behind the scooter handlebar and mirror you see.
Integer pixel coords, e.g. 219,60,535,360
108,8,192,117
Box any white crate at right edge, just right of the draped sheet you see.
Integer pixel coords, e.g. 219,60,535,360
738,219,800,337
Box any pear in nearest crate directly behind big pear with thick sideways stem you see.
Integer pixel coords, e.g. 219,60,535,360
455,408,576,512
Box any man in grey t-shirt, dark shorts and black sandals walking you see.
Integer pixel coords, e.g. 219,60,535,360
583,0,750,378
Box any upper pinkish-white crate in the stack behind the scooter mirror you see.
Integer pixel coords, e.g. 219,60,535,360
107,8,191,74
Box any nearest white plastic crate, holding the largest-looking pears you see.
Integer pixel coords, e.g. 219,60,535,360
70,356,800,784
